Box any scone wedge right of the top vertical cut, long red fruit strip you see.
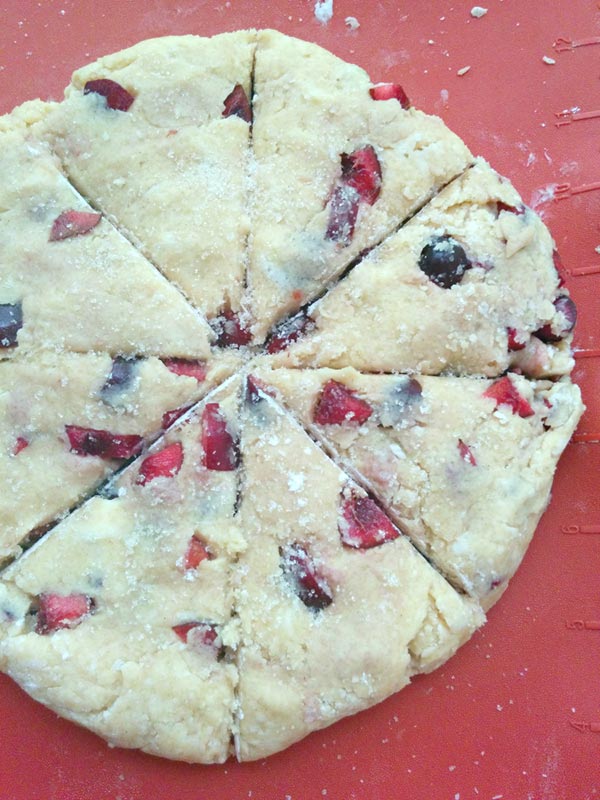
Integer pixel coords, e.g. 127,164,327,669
248,30,471,335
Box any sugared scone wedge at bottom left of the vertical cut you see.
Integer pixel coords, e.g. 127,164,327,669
0,379,241,762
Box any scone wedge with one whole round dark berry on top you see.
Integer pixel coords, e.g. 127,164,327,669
270,160,576,377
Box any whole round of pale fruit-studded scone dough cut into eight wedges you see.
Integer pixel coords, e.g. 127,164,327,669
0,31,582,763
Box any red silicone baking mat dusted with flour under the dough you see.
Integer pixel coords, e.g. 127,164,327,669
0,0,600,800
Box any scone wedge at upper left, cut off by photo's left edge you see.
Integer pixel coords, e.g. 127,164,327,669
0,111,212,359
